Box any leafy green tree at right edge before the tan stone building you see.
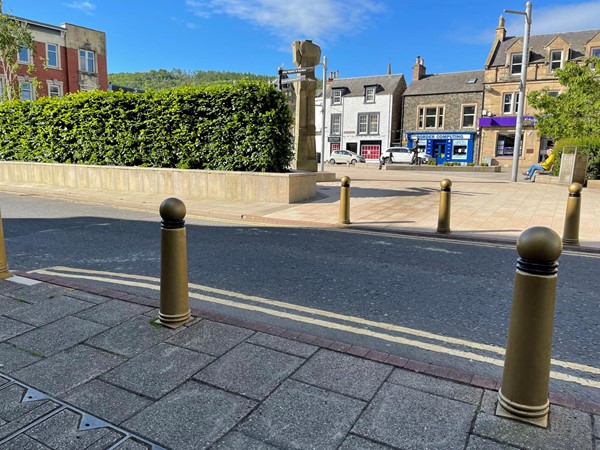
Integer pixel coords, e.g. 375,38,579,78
527,57,600,139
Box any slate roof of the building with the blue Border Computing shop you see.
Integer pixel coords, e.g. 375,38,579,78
404,70,484,97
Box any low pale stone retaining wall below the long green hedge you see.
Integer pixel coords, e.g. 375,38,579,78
0,161,316,203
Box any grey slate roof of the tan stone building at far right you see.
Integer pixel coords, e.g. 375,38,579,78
490,30,600,67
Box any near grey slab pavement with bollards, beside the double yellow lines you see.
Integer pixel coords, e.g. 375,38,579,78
0,273,600,450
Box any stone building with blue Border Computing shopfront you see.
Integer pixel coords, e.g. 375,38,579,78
402,56,483,164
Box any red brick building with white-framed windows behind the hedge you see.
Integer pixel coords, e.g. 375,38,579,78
5,17,108,100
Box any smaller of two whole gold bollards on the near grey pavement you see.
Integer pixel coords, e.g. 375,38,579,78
158,197,190,328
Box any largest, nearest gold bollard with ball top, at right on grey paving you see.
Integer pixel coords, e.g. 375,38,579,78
496,227,562,428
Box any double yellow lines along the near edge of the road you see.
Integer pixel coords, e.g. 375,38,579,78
31,266,600,388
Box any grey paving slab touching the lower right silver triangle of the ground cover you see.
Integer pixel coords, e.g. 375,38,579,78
64,380,152,424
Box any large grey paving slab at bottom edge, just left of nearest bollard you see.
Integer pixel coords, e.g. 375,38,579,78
352,383,476,449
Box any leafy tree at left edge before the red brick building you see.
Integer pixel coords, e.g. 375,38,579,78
0,9,35,100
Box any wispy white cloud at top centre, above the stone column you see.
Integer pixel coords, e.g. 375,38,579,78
186,0,383,42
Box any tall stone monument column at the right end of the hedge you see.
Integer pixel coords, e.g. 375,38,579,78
292,41,321,172
